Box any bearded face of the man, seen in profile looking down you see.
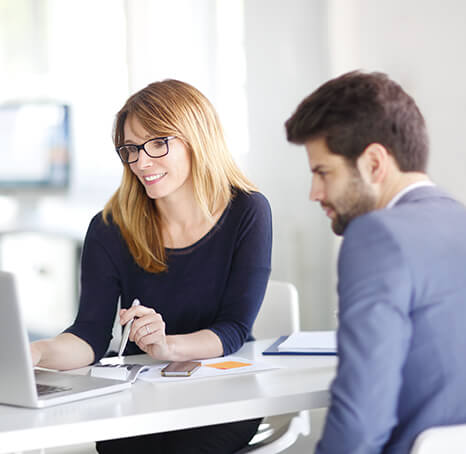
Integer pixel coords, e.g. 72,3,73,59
306,138,377,235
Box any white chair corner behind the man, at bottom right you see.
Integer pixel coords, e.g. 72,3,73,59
411,424,466,454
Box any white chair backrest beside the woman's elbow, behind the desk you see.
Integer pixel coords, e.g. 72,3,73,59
252,280,299,339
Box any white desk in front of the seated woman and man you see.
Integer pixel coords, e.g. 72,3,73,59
0,340,337,453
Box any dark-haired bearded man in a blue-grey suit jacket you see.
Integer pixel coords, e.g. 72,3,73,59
286,72,466,454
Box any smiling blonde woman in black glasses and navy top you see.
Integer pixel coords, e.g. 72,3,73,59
31,80,272,453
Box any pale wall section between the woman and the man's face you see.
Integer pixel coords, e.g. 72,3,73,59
245,0,335,329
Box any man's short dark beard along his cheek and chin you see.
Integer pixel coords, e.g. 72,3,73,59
324,172,376,235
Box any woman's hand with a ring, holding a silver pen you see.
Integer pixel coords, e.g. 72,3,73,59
120,306,173,361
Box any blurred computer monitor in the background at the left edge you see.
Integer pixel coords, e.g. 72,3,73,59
0,102,71,192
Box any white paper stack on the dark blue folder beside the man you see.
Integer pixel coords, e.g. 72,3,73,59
278,331,337,353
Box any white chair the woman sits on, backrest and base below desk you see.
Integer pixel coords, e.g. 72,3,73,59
237,280,311,454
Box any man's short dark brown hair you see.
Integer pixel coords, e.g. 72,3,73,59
285,71,429,172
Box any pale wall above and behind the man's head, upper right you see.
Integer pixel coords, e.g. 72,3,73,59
329,0,466,202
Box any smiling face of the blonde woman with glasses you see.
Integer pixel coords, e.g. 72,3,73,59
124,117,193,199
